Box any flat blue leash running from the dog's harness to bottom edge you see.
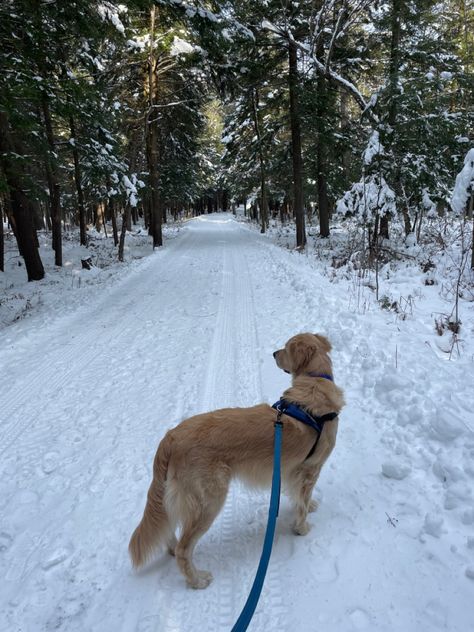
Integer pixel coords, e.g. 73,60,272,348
232,418,283,632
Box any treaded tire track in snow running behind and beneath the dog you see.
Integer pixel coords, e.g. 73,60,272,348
184,228,286,632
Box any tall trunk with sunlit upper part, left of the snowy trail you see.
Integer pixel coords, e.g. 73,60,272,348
146,6,163,248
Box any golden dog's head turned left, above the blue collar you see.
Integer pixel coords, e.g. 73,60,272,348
273,334,331,376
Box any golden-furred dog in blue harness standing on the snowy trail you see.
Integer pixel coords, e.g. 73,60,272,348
129,333,344,588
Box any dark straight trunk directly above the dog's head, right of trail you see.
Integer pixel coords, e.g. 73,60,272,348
288,41,306,248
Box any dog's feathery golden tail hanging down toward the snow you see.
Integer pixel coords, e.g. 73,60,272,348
128,435,173,568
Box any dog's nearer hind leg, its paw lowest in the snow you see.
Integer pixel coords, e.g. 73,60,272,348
175,472,230,588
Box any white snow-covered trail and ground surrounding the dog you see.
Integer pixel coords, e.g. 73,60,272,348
0,215,474,632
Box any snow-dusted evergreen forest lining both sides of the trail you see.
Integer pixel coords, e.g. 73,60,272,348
0,0,474,281
